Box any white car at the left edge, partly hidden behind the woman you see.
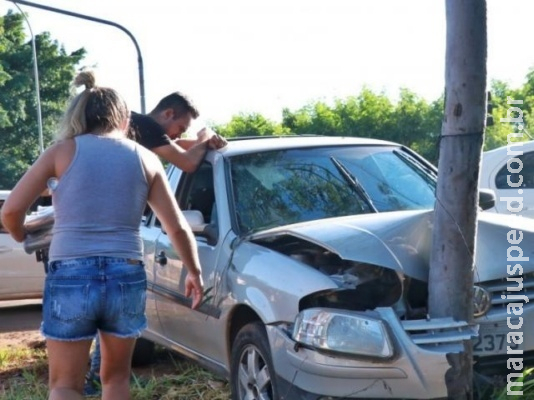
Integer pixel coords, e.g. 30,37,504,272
0,190,45,300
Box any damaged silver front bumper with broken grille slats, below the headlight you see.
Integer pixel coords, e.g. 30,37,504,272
267,308,477,400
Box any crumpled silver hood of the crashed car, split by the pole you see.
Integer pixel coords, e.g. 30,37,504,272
251,210,534,282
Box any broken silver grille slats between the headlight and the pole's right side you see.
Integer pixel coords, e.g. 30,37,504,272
401,317,477,353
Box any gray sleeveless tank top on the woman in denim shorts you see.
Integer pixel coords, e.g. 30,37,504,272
49,134,149,261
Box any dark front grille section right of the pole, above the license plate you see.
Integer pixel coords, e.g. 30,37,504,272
478,273,534,317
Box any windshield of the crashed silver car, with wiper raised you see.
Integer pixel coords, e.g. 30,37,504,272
230,146,435,234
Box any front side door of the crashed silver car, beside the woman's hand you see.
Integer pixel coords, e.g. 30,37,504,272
153,162,229,362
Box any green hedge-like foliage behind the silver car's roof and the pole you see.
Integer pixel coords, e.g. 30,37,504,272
216,76,534,164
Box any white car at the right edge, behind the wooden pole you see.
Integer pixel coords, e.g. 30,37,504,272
480,140,534,218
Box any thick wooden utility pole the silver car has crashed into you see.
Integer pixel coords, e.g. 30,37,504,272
429,0,487,400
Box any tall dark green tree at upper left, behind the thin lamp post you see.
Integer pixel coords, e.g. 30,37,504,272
0,11,85,189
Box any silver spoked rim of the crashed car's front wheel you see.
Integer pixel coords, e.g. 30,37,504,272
238,345,273,400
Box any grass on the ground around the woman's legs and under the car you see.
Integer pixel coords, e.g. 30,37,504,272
0,342,230,400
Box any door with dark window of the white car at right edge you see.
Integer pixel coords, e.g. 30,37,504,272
489,151,534,218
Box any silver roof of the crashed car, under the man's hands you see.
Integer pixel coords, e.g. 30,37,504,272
216,135,400,157
